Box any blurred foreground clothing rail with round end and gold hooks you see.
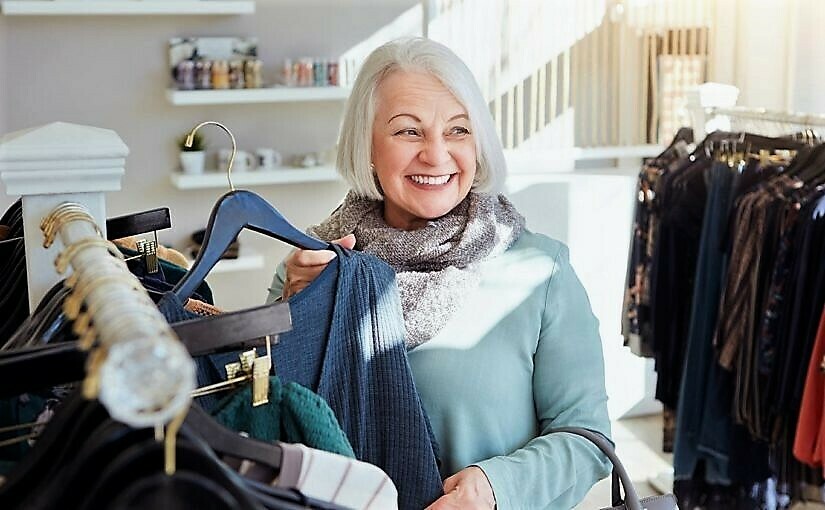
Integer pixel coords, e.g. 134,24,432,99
45,202,196,428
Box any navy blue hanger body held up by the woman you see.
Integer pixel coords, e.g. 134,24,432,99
172,190,329,301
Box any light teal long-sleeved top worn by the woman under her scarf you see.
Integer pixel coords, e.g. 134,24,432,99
408,231,610,510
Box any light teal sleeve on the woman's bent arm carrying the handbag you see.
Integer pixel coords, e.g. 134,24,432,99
476,246,610,510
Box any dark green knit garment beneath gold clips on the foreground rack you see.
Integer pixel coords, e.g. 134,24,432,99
213,376,355,458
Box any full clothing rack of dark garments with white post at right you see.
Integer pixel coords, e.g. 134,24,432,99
626,124,825,507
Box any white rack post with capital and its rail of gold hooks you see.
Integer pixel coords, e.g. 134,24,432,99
0,122,195,427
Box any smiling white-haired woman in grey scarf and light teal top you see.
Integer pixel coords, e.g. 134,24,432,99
270,38,610,509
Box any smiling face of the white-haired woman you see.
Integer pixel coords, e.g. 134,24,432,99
372,71,476,230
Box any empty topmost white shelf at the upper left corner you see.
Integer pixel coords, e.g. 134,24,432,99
0,0,255,16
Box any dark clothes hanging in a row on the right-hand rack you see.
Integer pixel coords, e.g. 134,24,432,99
623,129,825,509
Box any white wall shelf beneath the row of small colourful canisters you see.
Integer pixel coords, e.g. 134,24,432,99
166,87,350,106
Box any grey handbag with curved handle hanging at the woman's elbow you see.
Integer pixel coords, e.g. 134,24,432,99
549,427,679,510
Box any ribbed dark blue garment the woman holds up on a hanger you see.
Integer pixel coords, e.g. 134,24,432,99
159,245,442,510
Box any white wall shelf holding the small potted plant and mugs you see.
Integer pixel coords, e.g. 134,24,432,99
171,166,340,190
